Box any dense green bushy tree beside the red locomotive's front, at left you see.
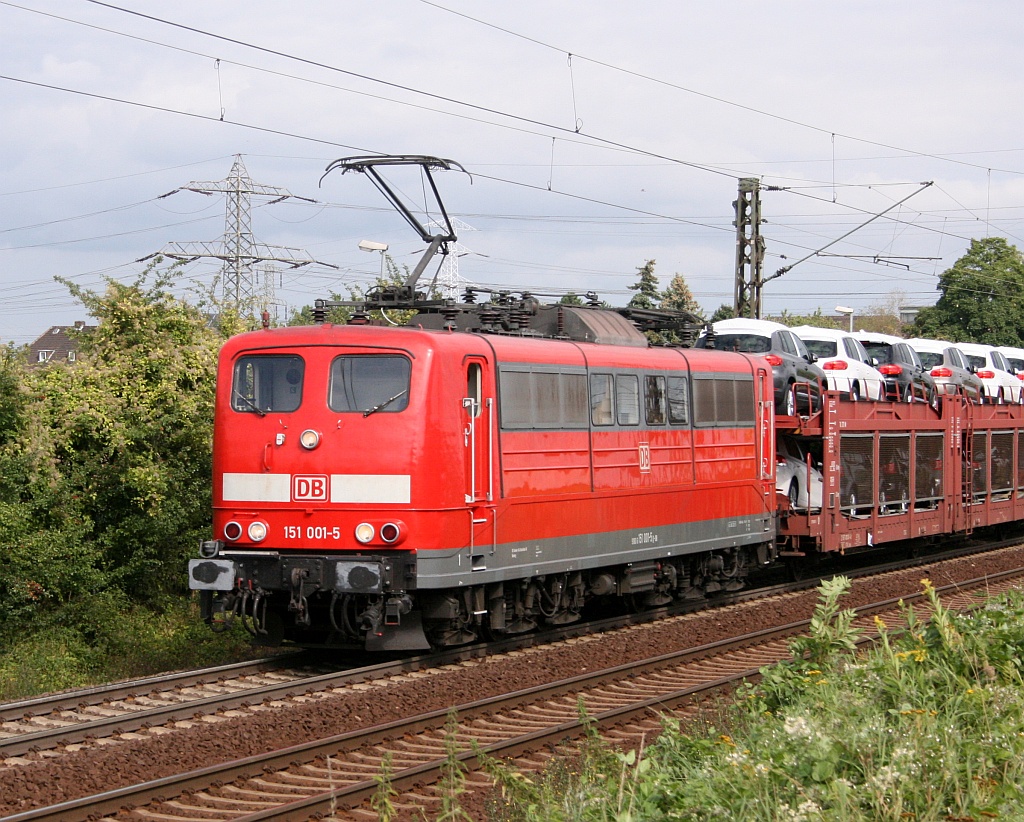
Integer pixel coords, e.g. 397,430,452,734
0,264,228,633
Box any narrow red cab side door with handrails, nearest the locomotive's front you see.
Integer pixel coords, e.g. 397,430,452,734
462,357,498,570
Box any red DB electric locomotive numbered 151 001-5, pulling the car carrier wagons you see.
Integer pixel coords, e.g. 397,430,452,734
189,300,775,650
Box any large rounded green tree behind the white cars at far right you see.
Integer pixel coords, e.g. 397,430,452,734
911,237,1024,346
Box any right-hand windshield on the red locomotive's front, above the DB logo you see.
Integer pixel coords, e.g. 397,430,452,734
328,354,412,415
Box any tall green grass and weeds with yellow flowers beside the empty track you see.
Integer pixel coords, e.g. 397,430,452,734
477,578,1024,822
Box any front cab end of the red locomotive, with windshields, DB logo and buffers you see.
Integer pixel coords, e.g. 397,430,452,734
189,326,489,650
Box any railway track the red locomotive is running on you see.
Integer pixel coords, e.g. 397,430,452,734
0,547,991,767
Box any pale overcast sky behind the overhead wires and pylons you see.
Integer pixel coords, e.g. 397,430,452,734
0,0,1024,343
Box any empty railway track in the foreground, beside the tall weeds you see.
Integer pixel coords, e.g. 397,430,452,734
10,552,1024,822
